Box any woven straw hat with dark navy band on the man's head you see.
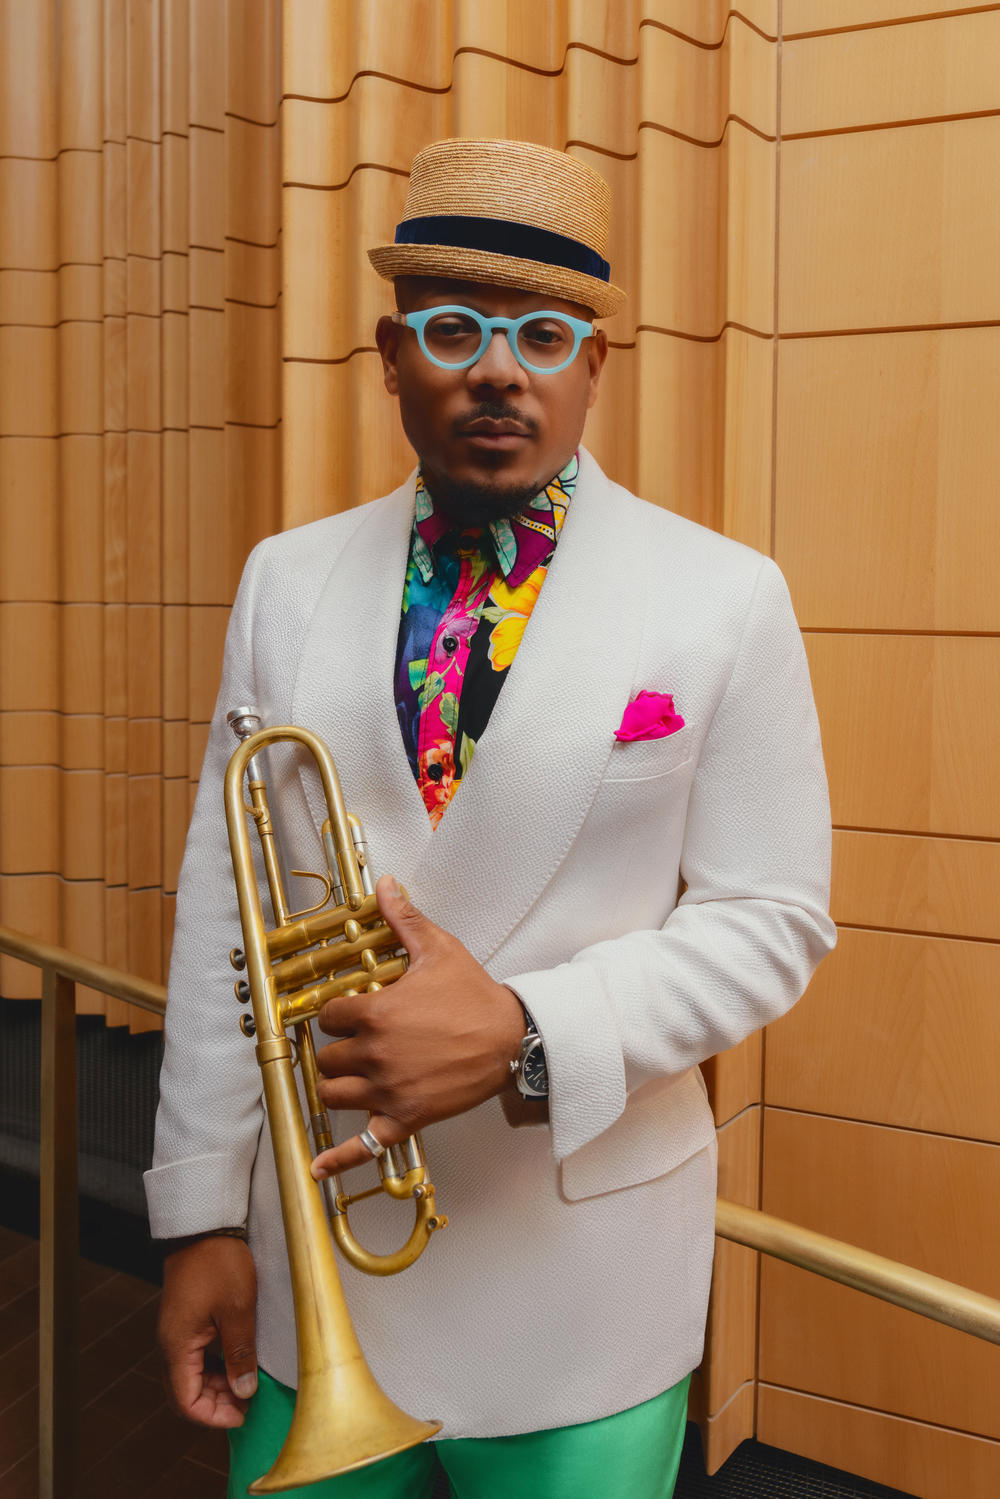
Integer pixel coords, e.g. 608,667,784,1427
369,139,625,318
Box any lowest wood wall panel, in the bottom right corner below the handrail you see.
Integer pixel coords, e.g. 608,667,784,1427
757,1379,1000,1499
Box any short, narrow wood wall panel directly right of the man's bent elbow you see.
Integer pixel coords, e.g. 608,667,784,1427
832,830,1000,941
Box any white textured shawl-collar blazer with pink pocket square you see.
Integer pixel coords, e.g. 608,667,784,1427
145,454,834,1436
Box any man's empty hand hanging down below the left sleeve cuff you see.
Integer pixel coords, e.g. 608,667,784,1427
157,1235,256,1427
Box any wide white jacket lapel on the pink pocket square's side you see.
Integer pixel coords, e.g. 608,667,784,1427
411,453,645,962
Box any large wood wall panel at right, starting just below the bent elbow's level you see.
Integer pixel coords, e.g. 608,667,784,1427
766,931,1000,1144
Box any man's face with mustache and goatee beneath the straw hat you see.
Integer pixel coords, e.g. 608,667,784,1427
376,276,607,523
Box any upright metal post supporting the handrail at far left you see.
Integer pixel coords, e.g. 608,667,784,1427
39,967,79,1499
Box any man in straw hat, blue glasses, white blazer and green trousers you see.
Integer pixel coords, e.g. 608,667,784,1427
147,141,834,1499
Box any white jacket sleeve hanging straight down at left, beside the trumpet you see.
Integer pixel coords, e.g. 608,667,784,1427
145,547,269,1238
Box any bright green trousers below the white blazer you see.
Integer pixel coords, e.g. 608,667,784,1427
228,1370,691,1499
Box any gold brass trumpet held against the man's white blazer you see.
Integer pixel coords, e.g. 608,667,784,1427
225,708,447,1493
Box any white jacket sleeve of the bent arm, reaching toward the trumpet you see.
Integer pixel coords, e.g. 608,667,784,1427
505,559,835,1160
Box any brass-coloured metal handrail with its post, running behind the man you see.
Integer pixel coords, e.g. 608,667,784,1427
0,926,1000,1499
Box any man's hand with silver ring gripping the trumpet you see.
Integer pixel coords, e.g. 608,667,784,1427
312,875,525,1178
